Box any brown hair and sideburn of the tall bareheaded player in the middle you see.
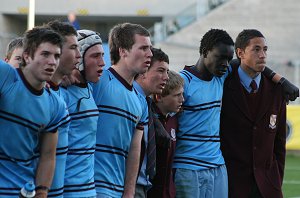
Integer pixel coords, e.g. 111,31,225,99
108,23,150,64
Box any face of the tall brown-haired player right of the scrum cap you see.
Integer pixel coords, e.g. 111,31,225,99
121,34,152,74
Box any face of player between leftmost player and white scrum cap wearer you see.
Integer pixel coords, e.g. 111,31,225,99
57,35,81,75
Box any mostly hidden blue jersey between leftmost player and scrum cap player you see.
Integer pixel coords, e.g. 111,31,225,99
48,82,69,198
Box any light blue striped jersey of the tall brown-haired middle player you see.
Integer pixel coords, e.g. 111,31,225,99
93,68,148,197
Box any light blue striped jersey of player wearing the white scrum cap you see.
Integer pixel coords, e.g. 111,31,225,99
62,84,99,198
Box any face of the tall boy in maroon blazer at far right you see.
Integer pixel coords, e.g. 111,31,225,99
237,37,268,77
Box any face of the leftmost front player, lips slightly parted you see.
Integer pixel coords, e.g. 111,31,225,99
23,42,61,90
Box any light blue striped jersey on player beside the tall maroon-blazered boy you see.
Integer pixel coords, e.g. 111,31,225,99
173,66,228,170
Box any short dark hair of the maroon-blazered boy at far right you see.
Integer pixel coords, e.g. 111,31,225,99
235,29,265,53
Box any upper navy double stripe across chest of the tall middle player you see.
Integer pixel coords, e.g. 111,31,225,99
97,105,138,123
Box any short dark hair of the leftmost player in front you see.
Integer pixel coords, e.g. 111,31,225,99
22,27,63,66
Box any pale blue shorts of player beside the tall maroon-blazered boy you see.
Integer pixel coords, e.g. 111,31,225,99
175,165,228,198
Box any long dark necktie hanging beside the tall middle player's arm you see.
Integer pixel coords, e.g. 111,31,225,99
146,97,156,180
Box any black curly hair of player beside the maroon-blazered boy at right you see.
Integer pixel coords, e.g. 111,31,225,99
199,29,234,57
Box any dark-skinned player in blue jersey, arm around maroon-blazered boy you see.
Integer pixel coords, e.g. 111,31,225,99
173,29,299,197
